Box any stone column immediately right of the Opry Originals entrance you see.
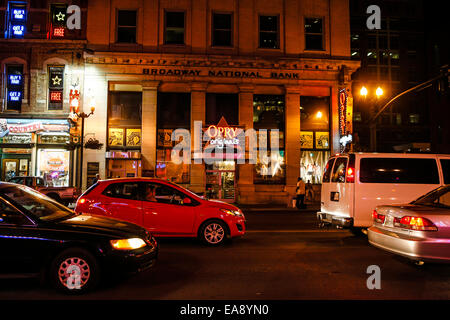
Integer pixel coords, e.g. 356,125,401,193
237,85,257,204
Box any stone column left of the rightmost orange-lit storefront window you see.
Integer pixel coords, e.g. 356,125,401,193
284,86,301,201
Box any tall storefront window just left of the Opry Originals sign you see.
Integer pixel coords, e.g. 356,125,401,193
155,92,191,184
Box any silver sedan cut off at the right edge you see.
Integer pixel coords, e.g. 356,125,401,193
367,185,450,263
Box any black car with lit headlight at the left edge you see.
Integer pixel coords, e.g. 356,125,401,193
0,182,158,293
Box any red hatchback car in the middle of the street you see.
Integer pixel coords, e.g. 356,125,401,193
75,178,245,245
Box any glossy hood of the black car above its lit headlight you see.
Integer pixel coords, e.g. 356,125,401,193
57,214,146,237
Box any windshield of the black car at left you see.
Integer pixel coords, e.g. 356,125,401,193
0,185,75,221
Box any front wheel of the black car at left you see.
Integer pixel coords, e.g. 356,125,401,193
50,248,100,294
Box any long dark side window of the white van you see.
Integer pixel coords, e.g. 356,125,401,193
359,158,439,184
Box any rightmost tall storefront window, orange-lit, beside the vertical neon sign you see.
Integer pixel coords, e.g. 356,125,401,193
300,96,331,184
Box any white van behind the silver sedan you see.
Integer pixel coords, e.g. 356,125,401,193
317,153,450,232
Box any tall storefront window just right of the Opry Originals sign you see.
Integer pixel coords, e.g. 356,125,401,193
253,95,286,184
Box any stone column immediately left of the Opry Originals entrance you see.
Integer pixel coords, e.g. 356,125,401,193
190,82,207,193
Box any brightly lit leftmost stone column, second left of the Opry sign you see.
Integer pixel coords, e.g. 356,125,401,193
141,80,159,175
